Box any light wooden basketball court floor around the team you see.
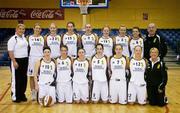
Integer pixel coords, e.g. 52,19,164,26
0,67,180,113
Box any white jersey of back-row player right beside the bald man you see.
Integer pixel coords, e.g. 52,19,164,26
130,38,144,57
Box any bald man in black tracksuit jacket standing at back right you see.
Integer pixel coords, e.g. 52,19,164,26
144,23,167,60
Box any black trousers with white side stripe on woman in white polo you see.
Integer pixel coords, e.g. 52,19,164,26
11,57,28,101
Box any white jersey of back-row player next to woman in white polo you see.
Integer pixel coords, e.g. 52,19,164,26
28,35,44,57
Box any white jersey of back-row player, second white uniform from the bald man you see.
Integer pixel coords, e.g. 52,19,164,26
115,36,130,57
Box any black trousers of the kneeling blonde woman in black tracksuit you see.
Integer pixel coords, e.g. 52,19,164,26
147,85,166,106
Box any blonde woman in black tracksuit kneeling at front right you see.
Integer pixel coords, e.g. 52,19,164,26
146,48,168,106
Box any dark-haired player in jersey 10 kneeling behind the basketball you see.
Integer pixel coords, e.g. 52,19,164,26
34,47,56,105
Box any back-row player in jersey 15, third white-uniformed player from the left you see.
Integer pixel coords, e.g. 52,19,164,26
62,22,80,58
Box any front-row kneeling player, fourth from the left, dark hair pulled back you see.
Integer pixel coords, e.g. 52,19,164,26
91,44,108,103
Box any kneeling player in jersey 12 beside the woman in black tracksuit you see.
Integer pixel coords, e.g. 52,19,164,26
128,45,147,105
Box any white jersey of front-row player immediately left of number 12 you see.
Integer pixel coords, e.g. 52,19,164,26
110,57,126,80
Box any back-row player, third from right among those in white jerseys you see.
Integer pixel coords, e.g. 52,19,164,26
99,26,113,57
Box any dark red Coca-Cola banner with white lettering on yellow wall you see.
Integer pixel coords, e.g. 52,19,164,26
0,8,64,20
